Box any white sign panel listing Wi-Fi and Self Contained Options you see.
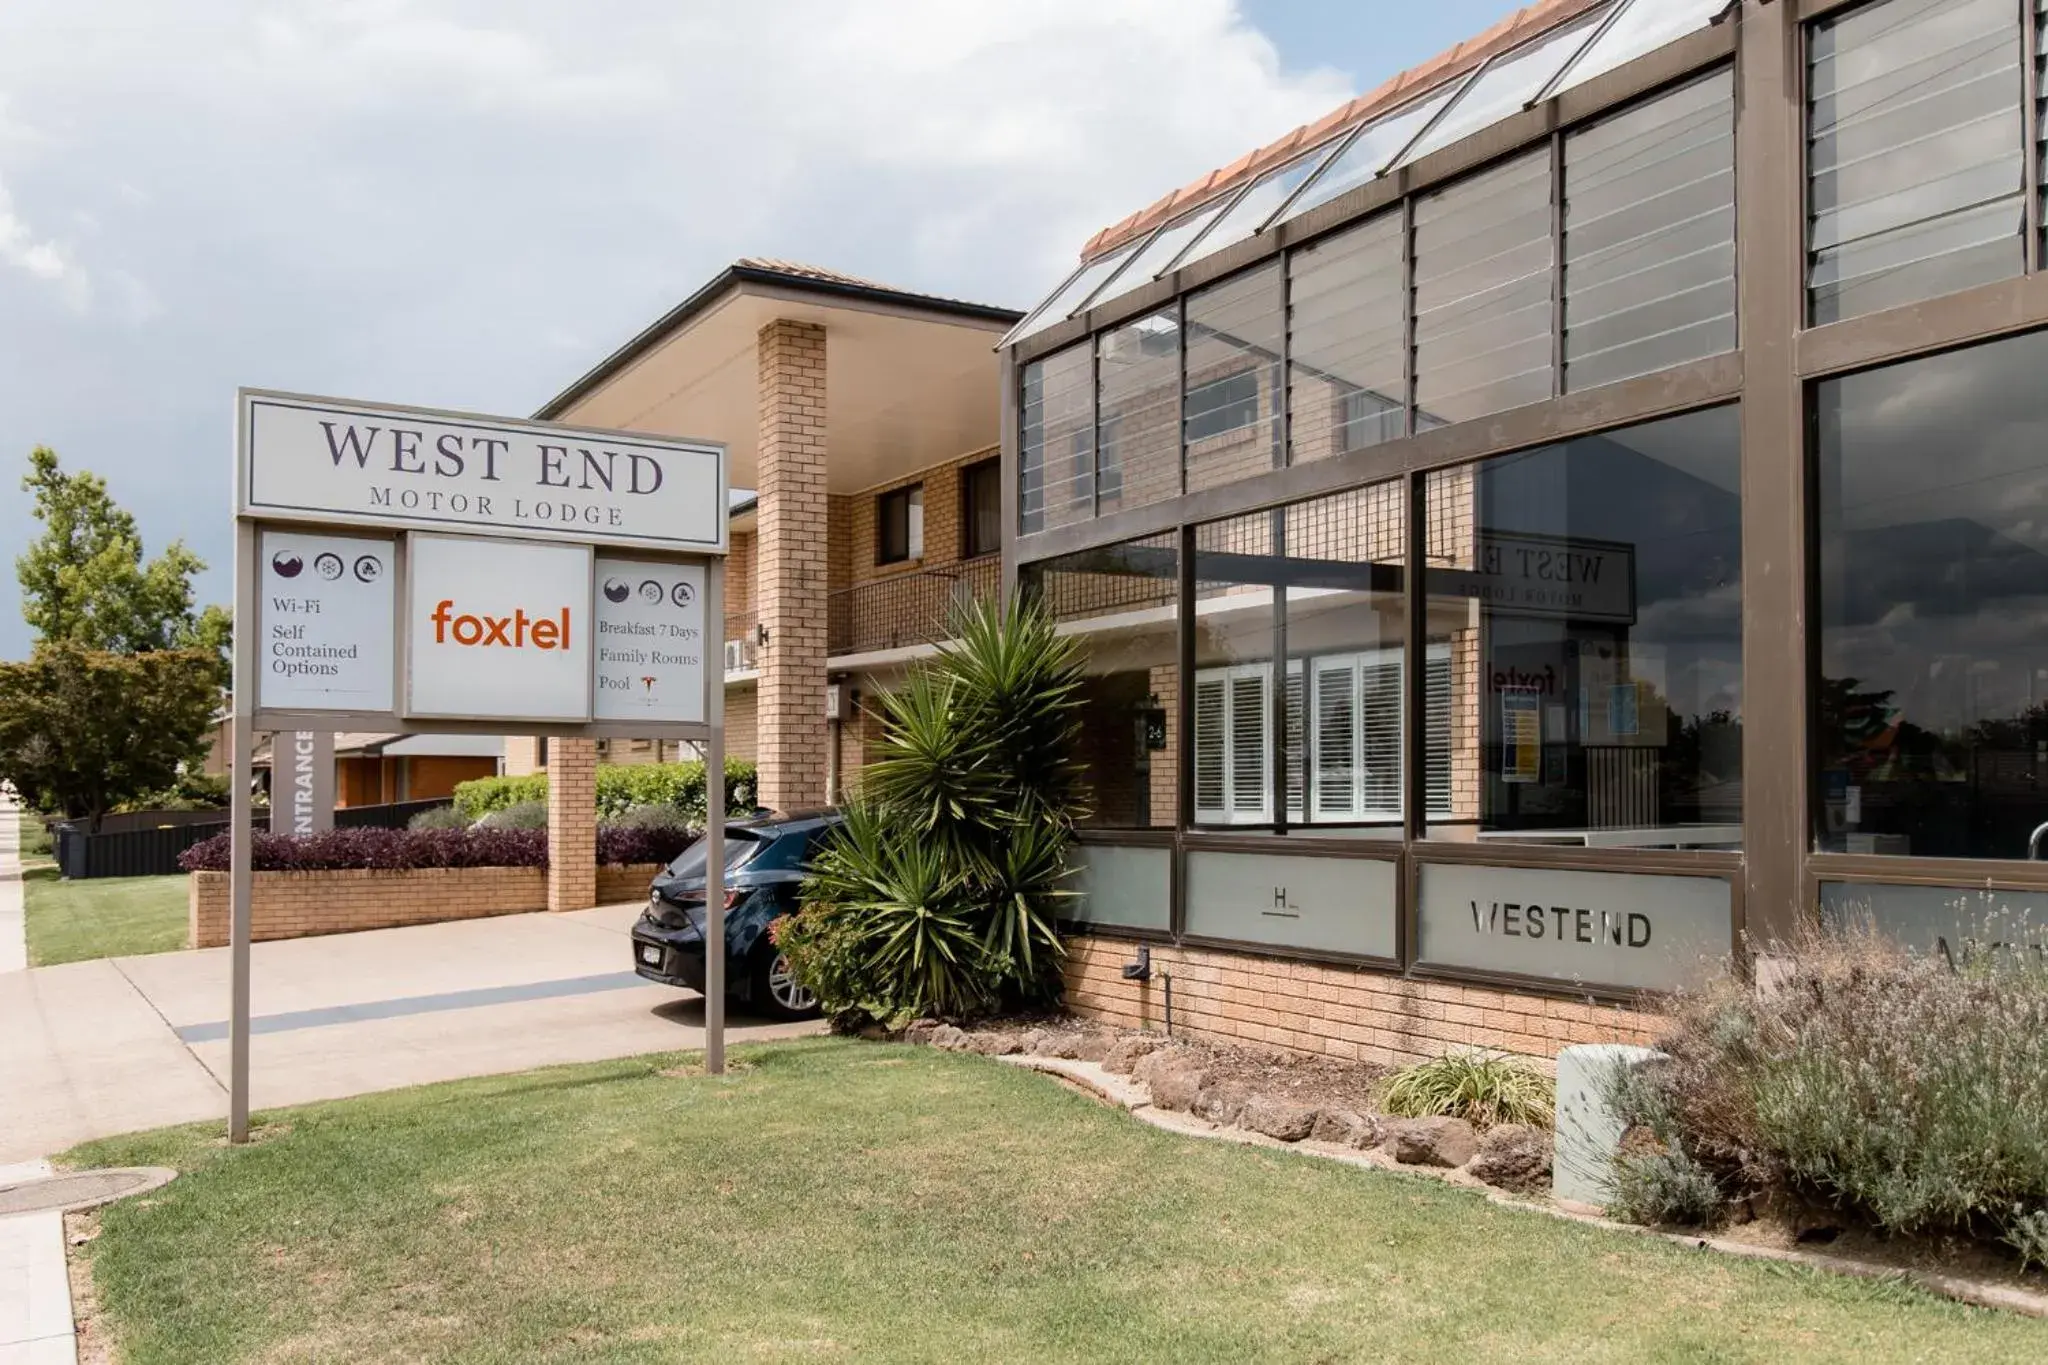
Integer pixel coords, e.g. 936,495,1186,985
256,530,397,712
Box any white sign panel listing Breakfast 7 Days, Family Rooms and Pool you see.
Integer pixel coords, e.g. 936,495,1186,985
594,559,705,720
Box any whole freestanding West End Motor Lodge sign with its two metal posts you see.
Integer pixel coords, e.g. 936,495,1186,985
227,389,729,1142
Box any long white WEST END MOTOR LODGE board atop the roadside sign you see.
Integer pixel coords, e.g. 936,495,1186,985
236,389,727,555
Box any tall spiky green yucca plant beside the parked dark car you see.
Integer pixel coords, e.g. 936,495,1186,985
776,602,1081,1023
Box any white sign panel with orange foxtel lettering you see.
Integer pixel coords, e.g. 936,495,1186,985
406,534,590,722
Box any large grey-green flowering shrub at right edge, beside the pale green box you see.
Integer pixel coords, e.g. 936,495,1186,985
1616,933,2048,1257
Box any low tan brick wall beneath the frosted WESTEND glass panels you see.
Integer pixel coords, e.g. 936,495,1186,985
1065,935,1659,1066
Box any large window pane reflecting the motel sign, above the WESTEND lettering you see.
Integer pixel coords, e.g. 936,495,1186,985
1427,407,1743,847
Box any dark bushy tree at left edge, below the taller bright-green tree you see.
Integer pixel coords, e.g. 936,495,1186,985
0,641,219,829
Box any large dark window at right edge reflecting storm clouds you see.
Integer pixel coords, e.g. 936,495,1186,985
1812,334,2048,857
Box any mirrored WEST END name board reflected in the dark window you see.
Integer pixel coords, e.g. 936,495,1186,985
1430,526,1636,626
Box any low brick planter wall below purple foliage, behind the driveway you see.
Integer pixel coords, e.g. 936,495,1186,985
186,864,659,948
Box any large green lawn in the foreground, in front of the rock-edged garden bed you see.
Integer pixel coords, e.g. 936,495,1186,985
68,1040,2048,1365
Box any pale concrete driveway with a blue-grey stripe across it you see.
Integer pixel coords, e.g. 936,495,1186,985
0,905,819,1162
